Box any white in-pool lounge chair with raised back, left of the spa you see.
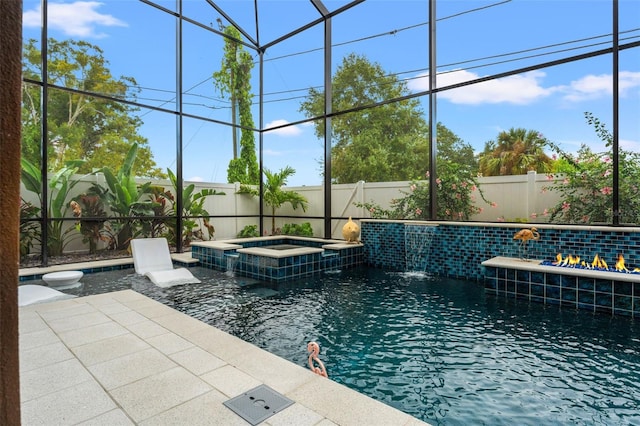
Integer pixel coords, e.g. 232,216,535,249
131,238,200,287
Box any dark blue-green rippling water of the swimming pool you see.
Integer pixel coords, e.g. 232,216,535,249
30,268,640,425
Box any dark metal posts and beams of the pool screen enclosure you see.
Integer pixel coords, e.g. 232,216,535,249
24,0,640,265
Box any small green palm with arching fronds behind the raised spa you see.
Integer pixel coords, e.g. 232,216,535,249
238,166,308,235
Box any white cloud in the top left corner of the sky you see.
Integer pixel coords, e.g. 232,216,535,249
22,1,127,38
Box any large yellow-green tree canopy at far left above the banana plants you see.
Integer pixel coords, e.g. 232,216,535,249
22,39,164,177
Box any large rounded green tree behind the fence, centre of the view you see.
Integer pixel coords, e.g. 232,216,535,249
300,54,475,183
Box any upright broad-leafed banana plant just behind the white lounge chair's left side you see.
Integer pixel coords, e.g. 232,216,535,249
92,144,154,250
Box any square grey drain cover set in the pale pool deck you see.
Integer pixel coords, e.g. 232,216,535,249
223,385,293,425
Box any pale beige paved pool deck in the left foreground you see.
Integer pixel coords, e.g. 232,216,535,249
19,290,426,426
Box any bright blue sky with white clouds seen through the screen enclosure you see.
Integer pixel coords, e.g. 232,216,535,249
23,0,640,185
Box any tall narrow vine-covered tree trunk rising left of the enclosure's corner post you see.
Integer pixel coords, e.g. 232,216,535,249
213,25,260,185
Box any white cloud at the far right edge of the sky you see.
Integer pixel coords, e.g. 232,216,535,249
562,71,640,102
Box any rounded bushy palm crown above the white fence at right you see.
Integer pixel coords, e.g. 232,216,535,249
479,128,553,176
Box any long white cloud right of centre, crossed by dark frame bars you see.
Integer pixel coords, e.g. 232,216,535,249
409,70,556,105
